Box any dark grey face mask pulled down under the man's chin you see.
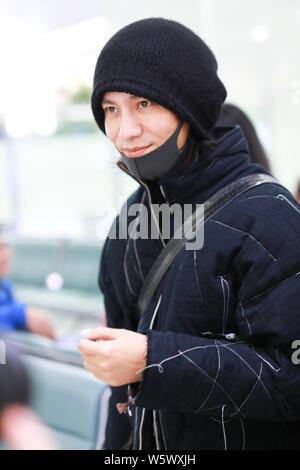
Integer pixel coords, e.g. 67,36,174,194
121,122,190,180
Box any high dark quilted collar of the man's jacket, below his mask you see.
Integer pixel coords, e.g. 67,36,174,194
118,126,267,204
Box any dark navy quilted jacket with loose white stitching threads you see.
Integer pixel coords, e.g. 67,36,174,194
100,127,300,449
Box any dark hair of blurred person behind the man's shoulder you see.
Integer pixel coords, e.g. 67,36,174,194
216,103,271,172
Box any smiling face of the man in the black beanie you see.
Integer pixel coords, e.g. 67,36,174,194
102,91,189,158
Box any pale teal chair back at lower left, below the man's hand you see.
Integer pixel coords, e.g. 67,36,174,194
2,332,110,450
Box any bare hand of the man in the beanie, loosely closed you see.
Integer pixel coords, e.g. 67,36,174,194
78,327,147,387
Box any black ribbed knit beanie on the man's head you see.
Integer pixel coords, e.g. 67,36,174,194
92,18,226,140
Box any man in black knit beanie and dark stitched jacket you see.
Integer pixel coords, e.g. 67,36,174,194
79,18,300,449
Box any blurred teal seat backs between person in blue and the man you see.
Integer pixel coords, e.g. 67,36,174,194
10,239,104,325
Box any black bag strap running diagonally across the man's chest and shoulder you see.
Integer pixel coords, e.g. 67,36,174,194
137,173,279,316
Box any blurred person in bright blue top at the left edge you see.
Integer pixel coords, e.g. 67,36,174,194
0,235,55,339
